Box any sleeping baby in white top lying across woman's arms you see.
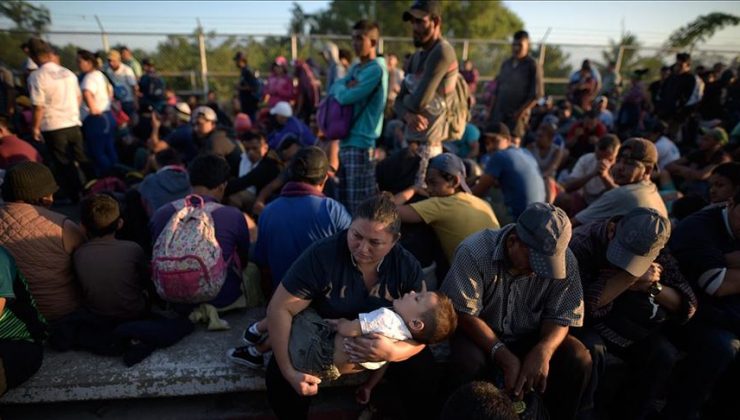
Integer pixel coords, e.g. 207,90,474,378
288,292,457,403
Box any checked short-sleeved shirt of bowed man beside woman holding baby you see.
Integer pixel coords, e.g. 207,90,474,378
441,224,584,342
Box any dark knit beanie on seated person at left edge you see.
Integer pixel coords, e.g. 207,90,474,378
2,161,59,202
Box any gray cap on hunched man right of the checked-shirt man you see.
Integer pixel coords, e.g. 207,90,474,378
606,207,671,277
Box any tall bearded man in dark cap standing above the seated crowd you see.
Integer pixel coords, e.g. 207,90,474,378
393,0,459,194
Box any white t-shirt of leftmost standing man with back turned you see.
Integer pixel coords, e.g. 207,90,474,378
28,61,81,131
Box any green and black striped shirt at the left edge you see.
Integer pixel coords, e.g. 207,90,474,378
0,247,46,341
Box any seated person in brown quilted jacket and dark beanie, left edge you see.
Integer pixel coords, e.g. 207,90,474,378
0,161,84,321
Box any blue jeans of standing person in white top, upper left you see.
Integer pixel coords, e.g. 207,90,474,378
82,111,118,176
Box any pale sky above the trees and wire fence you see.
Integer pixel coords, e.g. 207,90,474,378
0,1,740,56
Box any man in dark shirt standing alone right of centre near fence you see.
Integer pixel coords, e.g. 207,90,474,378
488,31,544,138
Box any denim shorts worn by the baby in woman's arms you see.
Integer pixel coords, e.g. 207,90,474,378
288,309,339,380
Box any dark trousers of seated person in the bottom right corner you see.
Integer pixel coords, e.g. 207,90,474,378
662,319,740,419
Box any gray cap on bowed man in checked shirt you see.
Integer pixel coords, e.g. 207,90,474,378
516,203,572,279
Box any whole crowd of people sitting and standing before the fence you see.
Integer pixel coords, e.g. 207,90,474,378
0,0,740,419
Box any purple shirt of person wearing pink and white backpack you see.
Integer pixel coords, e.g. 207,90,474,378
149,196,249,307
